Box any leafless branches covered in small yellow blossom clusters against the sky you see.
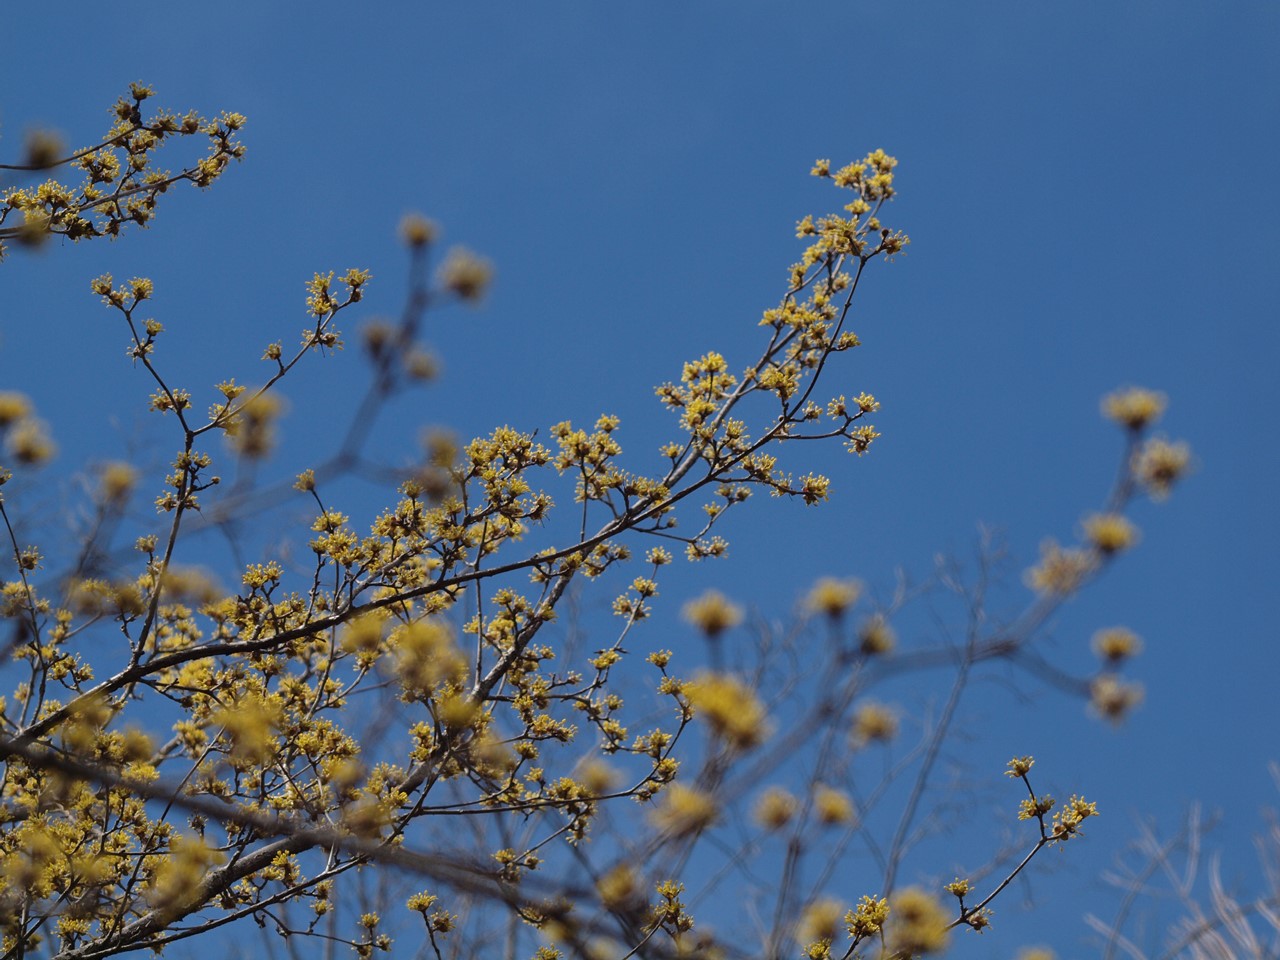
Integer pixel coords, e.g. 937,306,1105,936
0,84,1190,960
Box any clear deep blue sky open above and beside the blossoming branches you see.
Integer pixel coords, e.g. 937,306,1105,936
0,0,1280,956
